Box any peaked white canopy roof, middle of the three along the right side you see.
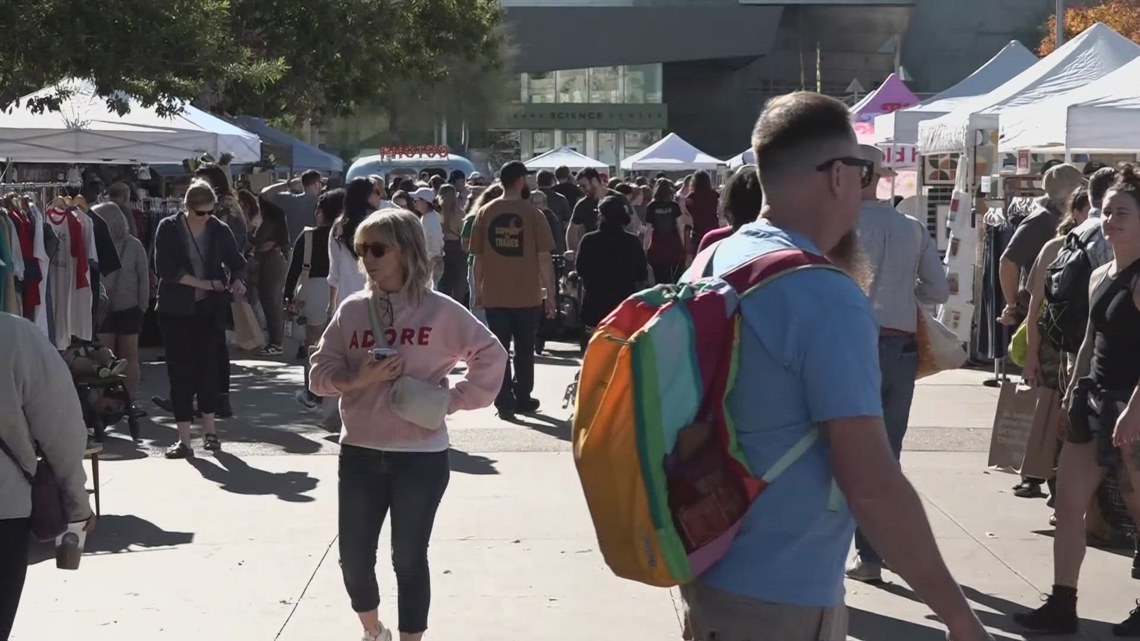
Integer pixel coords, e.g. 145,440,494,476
918,23,1140,155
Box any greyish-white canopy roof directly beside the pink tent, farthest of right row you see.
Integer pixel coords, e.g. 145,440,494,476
874,40,1037,145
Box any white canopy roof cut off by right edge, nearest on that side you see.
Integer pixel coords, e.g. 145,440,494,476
999,53,1140,154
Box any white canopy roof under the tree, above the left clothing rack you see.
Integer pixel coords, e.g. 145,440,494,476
0,80,261,164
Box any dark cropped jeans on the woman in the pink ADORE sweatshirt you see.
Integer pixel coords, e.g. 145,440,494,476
339,445,451,634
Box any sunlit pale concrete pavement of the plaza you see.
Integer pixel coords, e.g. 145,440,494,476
13,351,1134,641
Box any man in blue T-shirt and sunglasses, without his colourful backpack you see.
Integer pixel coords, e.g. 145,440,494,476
674,92,990,641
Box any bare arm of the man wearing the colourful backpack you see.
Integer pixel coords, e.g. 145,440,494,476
824,416,980,639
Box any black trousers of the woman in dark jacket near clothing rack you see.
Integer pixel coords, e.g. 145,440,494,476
158,302,228,423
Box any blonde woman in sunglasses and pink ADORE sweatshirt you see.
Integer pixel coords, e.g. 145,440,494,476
309,209,506,641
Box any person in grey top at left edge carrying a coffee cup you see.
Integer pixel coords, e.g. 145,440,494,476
0,314,95,639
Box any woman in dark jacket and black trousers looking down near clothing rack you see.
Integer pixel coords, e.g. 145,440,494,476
154,180,245,459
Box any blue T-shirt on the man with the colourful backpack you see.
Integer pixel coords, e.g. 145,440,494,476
684,220,882,607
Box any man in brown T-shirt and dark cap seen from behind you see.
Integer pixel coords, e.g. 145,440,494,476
471,161,555,420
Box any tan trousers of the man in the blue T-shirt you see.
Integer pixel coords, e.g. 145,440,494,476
681,582,847,641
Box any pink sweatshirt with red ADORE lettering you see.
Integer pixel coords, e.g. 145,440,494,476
309,285,506,452
